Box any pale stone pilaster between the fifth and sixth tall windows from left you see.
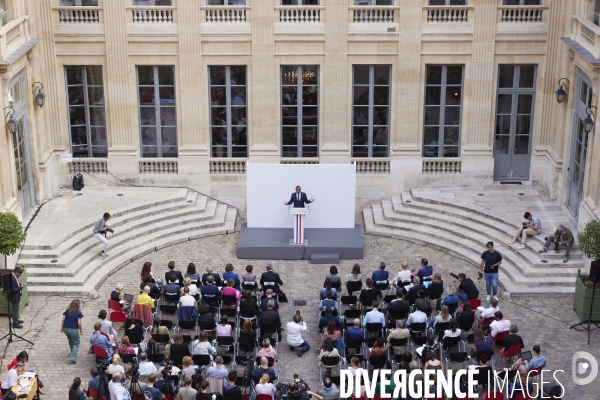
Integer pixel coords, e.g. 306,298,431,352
390,0,423,195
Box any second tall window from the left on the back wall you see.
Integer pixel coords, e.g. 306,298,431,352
137,66,177,157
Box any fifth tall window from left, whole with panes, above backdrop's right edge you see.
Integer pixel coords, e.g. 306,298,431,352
352,65,392,157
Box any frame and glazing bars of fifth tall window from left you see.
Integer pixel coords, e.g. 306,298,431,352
351,64,392,159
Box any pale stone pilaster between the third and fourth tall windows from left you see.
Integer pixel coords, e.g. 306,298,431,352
248,0,281,163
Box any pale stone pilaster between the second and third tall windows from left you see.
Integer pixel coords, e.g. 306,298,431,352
176,0,210,186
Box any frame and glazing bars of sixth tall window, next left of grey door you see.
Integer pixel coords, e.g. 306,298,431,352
421,64,465,159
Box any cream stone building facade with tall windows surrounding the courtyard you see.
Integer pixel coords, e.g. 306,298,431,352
0,0,600,231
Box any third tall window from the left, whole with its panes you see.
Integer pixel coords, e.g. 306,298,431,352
209,66,248,157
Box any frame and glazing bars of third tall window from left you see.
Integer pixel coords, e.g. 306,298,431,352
208,65,248,159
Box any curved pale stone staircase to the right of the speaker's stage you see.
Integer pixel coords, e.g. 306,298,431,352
363,189,584,296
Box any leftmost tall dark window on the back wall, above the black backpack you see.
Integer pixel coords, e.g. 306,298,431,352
65,65,108,157
